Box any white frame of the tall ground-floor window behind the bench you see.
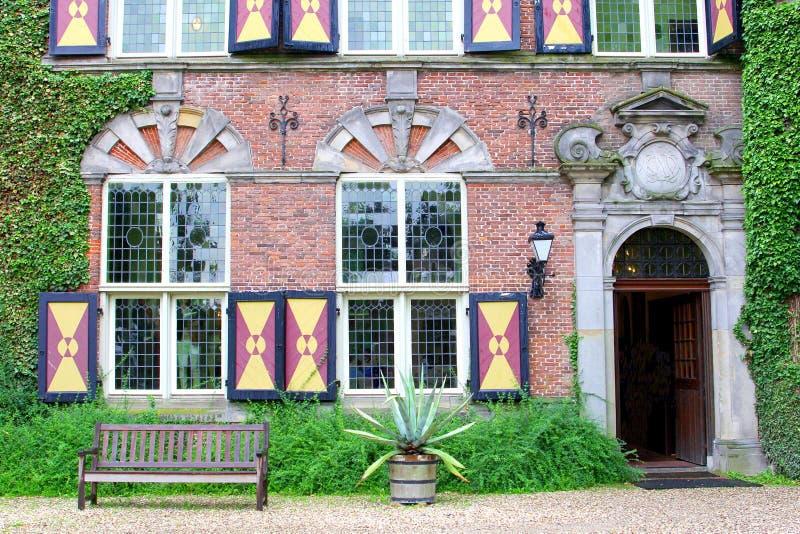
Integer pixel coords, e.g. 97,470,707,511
98,174,231,399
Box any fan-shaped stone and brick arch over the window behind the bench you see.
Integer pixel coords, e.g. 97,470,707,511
81,102,253,176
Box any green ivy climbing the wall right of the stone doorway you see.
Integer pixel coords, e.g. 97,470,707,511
737,0,800,478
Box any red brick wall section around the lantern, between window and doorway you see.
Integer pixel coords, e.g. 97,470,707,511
467,181,574,396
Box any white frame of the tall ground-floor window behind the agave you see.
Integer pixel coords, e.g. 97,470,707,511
336,173,470,397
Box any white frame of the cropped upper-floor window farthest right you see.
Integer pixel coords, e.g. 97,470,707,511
590,0,708,58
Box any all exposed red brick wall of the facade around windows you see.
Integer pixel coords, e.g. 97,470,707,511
86,62,741,396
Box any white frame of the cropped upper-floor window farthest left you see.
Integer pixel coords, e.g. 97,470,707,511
109,0,228,59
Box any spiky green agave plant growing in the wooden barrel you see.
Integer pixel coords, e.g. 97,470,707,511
344,374,475,484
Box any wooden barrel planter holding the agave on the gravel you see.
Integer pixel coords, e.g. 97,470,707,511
389,454,439,504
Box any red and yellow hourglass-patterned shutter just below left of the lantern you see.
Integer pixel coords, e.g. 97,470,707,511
469,293,528,400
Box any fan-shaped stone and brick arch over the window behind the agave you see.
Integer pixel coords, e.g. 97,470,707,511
314,107,493,173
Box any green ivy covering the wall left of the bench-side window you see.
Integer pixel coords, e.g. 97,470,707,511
0,0,152,409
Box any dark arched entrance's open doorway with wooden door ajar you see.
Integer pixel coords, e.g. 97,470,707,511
614,280,709,465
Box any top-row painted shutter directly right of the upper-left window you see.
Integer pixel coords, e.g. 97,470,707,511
228,0,280,52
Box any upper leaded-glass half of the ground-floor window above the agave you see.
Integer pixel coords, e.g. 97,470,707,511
339,177,466,286
